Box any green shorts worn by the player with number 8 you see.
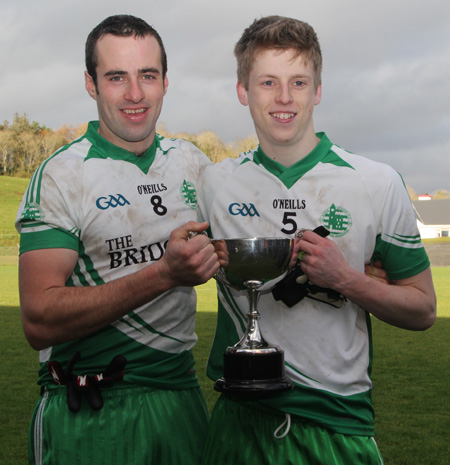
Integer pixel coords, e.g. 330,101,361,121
28,385,208,465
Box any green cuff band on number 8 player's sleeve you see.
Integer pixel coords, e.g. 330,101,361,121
20,228,79,254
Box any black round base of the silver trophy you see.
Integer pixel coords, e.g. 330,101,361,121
214,348,294,395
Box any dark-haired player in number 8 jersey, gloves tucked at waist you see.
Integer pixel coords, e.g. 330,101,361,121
16,16,218,465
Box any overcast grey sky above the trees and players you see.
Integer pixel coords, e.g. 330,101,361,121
0,0,450,194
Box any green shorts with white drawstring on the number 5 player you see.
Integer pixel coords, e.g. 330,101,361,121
201,395,383,465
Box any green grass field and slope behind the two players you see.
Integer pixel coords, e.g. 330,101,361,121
0,176,450,465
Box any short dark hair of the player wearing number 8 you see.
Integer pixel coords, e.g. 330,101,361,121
85,15,167,85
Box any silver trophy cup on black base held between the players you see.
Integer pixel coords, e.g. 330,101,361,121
212,238,294,395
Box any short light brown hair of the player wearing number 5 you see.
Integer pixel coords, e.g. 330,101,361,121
234,16,322,89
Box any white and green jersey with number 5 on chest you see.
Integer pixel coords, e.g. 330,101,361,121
198,133,429,435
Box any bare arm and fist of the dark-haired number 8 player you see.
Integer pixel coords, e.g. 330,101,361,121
19,222,219,350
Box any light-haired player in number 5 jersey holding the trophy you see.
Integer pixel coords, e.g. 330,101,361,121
199,16,436,465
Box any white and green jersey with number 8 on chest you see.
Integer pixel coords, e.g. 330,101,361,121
16,122,210,389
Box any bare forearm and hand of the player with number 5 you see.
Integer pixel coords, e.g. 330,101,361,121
298,231,436,330
